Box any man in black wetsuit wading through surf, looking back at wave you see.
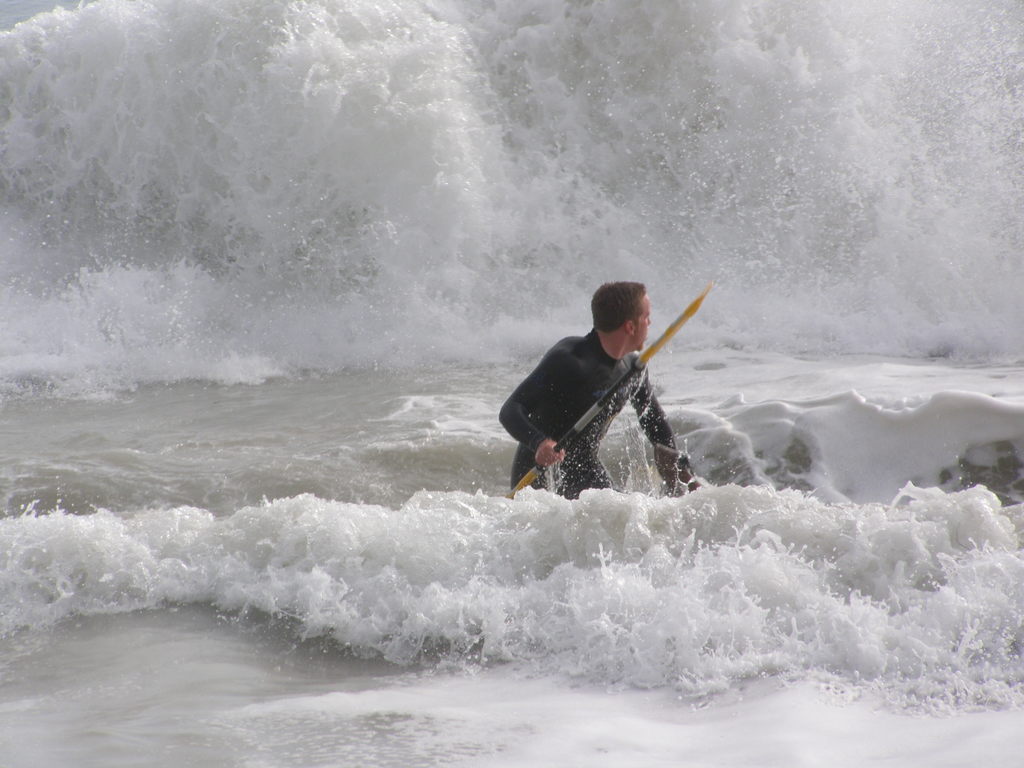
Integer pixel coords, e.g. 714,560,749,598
499,283,698,499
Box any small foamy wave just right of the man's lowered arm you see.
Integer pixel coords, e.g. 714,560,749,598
686,392,1024,502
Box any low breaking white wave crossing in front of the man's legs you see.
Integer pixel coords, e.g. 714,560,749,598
0,486,1024,710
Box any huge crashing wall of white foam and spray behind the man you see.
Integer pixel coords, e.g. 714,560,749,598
0,0,1024,388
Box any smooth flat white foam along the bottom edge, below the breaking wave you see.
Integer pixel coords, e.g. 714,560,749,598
227,671,1020,768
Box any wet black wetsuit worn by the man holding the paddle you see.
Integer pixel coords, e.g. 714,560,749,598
499,331,676,499
